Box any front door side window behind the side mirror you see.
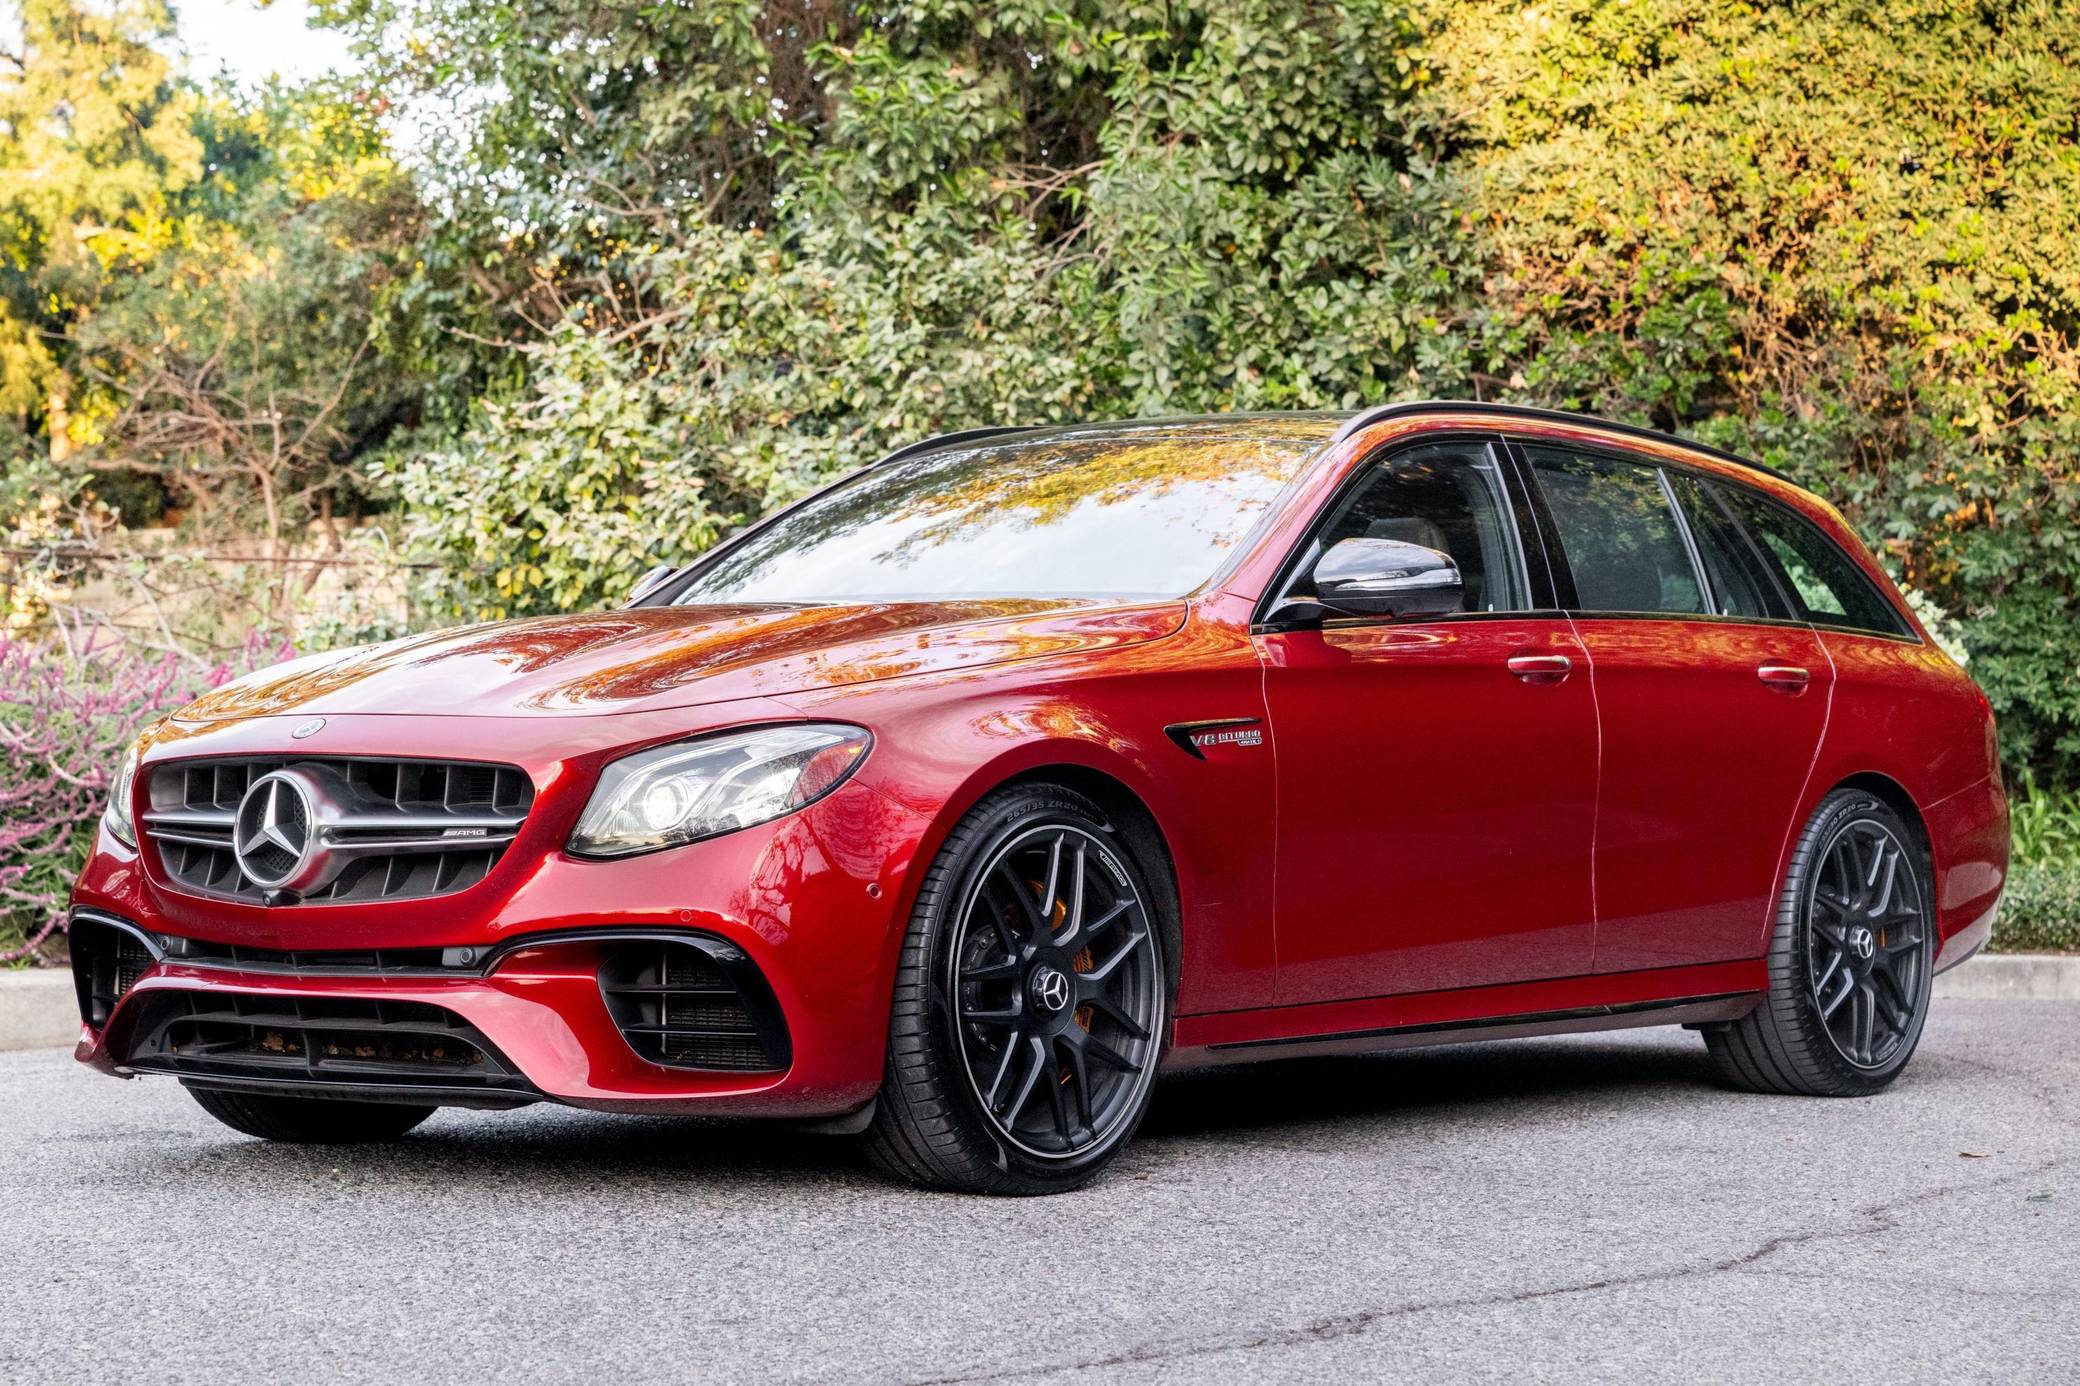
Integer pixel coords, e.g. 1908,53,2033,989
1300,443,1531,612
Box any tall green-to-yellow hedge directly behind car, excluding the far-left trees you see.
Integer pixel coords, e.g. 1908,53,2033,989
337,0,2080,776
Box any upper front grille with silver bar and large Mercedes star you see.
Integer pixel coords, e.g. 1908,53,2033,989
144,758,535,903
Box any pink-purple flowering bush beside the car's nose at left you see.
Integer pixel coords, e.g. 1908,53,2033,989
0,624,289,964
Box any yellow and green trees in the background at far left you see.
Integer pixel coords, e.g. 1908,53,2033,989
0,0,424,543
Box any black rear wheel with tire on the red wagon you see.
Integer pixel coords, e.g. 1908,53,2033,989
1704,789,1936,1097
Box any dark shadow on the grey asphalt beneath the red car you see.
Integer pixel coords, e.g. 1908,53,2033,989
121,1023,1718,1195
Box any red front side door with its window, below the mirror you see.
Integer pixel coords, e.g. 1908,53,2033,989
1256,441,1595,1005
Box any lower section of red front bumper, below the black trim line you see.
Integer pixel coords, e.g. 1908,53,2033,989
73,914,823,1113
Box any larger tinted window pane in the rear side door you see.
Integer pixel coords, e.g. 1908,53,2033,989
1525,447,1706,616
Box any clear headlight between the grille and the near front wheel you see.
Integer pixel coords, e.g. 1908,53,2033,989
570,722,874,857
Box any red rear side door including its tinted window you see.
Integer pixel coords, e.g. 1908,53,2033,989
1520,443,1832,972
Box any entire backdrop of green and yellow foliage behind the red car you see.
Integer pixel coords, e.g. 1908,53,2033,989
0,0,2080,948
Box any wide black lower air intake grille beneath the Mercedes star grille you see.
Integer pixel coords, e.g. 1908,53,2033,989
125,991,532,1099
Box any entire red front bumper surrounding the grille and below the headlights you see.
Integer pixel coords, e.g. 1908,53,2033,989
73,765,926,1118
